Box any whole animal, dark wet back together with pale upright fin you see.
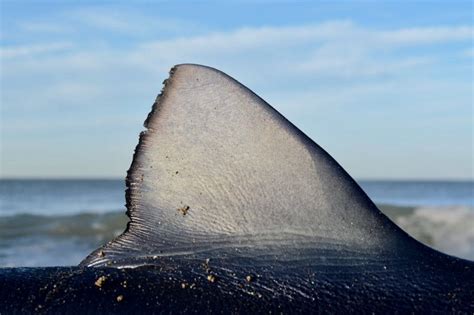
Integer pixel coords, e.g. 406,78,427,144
0,65,474,314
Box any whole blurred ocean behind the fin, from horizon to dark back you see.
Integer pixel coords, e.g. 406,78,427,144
0,180,474,267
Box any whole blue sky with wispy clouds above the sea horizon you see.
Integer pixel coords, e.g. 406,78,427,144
0,0,474,180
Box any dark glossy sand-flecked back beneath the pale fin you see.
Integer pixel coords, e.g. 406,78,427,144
0,253,474,314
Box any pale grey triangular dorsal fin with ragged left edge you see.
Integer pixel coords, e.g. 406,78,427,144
82,65,418,266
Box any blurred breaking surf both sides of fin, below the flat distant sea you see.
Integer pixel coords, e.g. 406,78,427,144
0,205,474,266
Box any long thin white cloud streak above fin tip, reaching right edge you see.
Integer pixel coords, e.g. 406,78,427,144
134,21,474,54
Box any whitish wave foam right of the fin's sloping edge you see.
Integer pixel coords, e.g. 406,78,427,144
395,206,474,260
